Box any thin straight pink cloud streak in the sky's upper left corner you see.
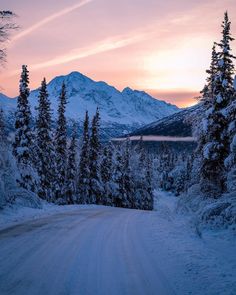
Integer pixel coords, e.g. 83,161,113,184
11,0,94,45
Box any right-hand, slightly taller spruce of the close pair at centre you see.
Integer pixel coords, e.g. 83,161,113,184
89,108,102,204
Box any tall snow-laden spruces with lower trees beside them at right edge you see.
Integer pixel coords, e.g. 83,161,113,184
151,12,236,198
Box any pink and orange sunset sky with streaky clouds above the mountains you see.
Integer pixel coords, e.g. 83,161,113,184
0,0,236,107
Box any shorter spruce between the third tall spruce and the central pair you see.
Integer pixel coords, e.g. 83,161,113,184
65,125,77,204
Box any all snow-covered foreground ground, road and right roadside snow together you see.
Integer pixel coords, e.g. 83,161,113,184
0,191,236,295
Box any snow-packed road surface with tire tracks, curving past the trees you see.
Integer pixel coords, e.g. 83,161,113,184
0,207,174,295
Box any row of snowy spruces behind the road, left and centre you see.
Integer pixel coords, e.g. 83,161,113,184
0,65,153,210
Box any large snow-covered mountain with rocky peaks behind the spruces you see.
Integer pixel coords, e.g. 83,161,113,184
0,72,179,138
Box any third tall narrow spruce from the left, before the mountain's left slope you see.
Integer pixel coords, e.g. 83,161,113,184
54,82,67,204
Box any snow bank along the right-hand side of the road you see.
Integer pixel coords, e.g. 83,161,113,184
150,191,236,295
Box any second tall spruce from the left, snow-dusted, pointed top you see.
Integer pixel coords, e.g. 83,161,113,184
36,78,55,201
